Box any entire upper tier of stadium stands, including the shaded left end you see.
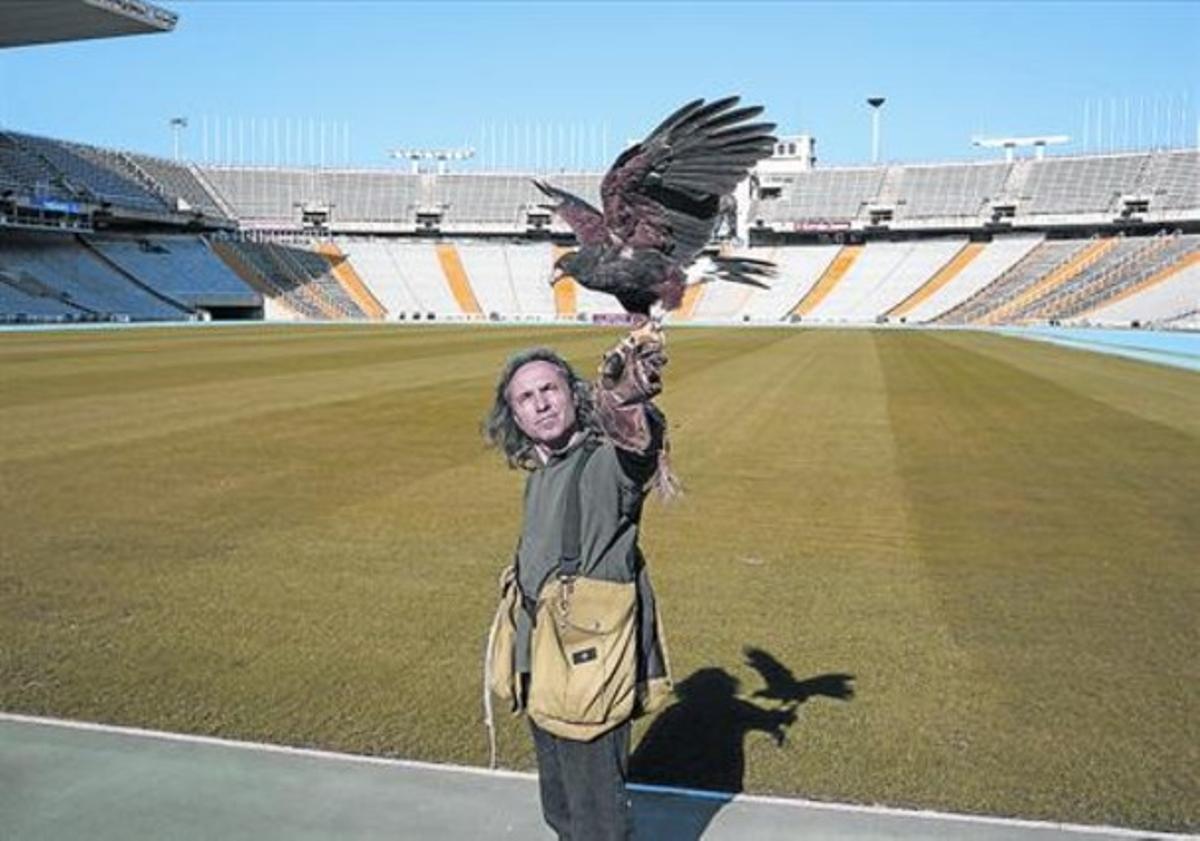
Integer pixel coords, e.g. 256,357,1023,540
0,132,1200,234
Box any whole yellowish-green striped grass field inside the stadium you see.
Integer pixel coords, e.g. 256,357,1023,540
0,326,1200,829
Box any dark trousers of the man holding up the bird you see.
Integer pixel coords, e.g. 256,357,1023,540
529,719,634,841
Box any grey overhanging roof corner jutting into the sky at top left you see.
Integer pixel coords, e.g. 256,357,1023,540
0,0,179,48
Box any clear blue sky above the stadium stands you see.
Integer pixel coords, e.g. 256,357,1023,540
0,0,1200,168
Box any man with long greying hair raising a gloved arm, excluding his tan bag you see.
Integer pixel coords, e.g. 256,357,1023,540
485,324,676,841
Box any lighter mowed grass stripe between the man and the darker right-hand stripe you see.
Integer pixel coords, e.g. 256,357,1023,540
647,331,990,803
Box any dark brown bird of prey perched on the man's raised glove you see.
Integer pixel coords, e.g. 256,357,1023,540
534,96,775,316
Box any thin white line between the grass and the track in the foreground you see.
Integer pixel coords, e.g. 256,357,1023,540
0,711,1200,841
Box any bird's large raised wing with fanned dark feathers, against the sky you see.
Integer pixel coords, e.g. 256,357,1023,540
600,96,775,264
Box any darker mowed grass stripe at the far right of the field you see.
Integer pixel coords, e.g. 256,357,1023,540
877,332,1200,828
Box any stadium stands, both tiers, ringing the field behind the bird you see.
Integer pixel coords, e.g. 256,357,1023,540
0,131,1200,328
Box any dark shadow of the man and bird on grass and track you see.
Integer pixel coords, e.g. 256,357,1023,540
629,647,854,841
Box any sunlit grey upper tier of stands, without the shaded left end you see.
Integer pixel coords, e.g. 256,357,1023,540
192,150,1200,233
